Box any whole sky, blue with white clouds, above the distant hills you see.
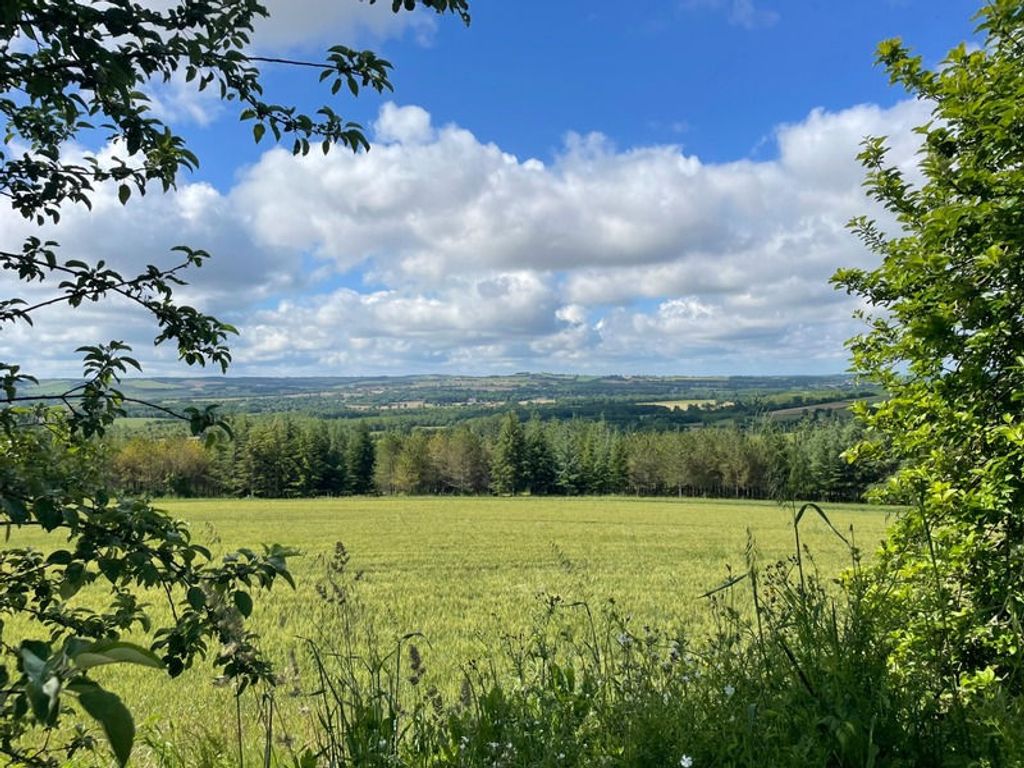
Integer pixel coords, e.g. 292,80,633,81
0,0,979,376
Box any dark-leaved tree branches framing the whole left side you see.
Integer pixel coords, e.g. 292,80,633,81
0,0,468,766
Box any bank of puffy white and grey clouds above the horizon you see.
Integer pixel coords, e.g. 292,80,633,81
0,101,928,374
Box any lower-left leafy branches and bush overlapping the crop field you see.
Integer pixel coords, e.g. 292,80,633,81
0,414,291,765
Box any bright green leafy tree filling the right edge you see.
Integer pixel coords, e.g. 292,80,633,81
835,0,1024,701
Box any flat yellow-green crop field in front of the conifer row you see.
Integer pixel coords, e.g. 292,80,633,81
9,497,886,757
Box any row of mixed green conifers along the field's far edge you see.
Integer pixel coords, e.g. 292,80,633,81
110,413,891,501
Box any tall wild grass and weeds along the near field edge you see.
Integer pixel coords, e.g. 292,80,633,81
253,507,1024,768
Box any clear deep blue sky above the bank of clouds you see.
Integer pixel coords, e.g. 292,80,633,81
189,0,979,184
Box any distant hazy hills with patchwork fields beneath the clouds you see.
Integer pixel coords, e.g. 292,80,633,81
24,373,878,434
